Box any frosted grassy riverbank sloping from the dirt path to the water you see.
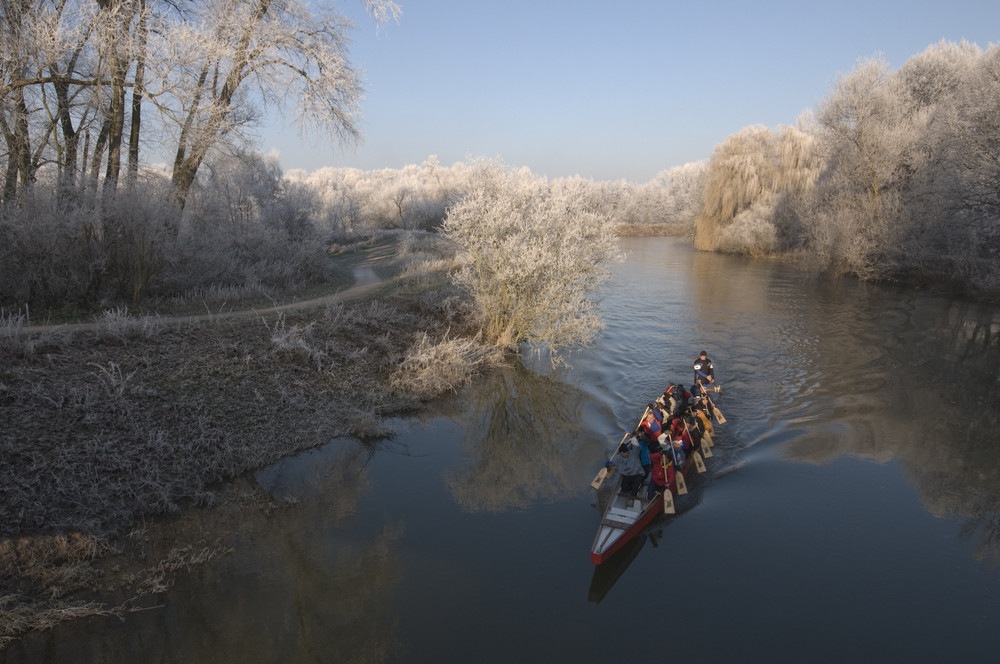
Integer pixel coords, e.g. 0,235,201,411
0,232,495,647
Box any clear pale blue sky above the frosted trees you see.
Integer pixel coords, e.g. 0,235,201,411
259,0,1000,182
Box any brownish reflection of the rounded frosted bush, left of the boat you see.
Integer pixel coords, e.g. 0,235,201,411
446,363,605,512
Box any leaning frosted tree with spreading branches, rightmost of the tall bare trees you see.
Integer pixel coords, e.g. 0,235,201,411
164,0,399,205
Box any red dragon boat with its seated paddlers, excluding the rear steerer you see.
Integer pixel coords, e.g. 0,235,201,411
590,384,725,565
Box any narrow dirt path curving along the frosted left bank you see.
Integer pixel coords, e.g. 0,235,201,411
14,245,396,334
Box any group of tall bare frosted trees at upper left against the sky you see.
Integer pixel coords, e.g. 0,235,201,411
0,0,400,203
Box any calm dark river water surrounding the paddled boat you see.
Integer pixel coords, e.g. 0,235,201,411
6,238,1000,663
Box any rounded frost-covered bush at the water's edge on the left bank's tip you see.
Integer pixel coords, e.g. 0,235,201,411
442,160,618,349
